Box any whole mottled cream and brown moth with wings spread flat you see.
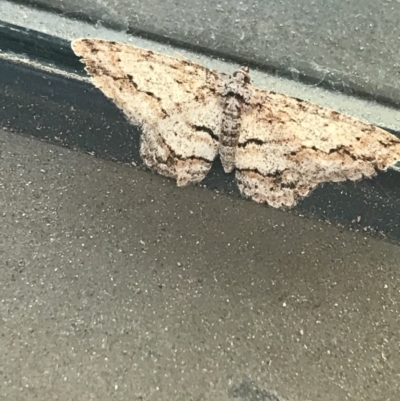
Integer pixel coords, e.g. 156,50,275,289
72,39,400,207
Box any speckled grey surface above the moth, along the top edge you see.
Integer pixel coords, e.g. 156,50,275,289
7,0,400,102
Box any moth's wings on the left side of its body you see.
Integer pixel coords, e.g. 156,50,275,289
72,39,222,185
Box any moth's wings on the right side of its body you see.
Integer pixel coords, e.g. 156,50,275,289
235,90,400,207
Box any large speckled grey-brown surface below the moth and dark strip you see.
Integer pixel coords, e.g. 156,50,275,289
0,131,400,401
